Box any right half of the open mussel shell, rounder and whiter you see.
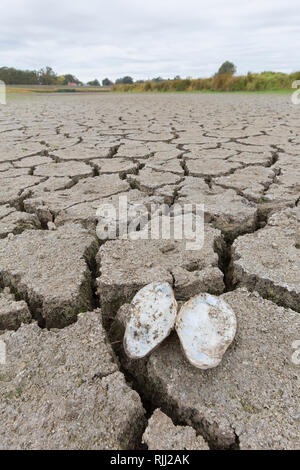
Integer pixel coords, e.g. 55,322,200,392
175,294,237,369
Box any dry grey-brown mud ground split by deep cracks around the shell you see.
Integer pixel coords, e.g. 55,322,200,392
0,94,300,449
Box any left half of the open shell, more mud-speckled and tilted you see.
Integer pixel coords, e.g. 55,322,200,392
123,282,177,359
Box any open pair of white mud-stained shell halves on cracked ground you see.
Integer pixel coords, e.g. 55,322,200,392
124,282,237,369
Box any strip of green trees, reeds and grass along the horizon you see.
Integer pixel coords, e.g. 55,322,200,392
0,60,300,93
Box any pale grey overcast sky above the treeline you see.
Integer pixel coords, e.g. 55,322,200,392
0,0,300,81
